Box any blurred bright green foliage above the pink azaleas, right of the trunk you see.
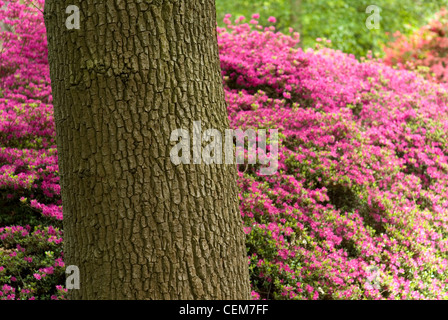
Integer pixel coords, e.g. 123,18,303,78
216,0,448,57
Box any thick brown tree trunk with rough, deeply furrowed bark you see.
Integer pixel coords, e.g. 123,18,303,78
44,0,250,299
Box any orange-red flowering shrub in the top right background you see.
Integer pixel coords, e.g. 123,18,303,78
384,9,448,82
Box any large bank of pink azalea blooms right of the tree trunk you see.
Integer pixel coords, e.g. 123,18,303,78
218,16,448,299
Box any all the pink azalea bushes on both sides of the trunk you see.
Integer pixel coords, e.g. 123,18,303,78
0,0,448,299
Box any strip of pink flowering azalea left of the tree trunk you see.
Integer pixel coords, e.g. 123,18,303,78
0,0,66,300
